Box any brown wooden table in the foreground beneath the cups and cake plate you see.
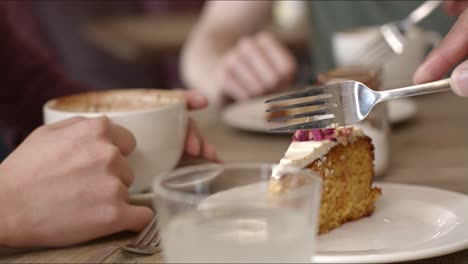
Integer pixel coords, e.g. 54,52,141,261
0,93,468,263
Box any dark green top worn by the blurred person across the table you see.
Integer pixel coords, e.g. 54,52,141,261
307,1,455,72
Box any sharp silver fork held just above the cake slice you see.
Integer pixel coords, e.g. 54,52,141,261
265,78,451,132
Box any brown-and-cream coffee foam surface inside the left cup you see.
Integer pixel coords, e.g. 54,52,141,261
49,89,184,113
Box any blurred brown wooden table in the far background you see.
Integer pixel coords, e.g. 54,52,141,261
83,13,309,62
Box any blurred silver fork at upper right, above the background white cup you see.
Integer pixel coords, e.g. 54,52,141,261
359,0,442,65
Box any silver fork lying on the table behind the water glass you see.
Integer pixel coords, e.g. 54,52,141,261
83,214,161,263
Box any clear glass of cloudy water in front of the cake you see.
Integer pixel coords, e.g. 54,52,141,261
153,163,321,263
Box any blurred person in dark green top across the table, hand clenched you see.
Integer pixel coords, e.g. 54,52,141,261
181,1,460,104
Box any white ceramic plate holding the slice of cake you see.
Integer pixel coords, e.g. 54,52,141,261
313,183,468,263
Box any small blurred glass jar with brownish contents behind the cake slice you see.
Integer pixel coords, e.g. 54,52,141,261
318,66,390,176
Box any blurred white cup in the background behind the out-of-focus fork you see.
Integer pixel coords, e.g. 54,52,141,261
332,27,442,89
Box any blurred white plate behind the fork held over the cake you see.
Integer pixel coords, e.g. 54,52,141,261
223,95,417,133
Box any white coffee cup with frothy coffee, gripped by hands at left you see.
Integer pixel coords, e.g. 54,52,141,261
43,89,188,193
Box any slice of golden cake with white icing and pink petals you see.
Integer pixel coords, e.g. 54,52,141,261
270,127,381,234
